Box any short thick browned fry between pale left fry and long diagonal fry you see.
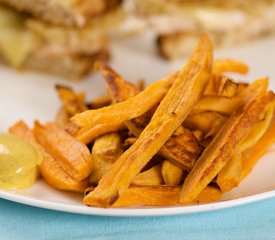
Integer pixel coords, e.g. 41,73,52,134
89,133,122,185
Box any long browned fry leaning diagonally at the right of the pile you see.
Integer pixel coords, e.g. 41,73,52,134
180,88,273,204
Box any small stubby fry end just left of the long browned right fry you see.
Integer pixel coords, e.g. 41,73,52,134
161,160,184,186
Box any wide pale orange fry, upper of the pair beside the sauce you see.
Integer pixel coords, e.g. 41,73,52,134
33,121,92,181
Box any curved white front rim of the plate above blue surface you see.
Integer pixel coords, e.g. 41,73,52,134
0,190,275,217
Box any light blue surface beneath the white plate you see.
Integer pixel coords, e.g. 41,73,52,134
0,198,275,240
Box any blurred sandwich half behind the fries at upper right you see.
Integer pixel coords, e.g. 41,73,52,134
135,0,275,59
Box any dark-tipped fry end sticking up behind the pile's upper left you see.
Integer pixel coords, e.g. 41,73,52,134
55,85,87,117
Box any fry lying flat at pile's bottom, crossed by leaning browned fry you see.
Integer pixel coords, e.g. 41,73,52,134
111,185,222,208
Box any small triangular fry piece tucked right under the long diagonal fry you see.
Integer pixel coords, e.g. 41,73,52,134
131,164,163,187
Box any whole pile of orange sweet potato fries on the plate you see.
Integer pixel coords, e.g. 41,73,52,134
10,35,275,207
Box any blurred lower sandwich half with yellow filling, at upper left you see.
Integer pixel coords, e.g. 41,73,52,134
0,5,111,79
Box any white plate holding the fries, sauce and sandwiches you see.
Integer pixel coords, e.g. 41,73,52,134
0,36,275,216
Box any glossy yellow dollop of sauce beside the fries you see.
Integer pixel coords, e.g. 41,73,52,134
0,134,42,189
